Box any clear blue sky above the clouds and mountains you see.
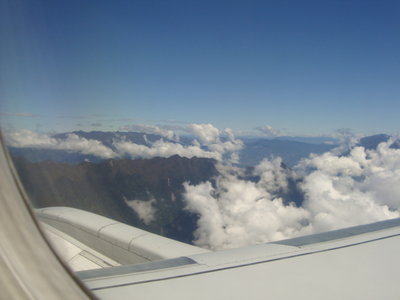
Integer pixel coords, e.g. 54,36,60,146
0,0,400,135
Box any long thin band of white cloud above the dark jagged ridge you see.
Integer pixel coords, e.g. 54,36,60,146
6,124,243,162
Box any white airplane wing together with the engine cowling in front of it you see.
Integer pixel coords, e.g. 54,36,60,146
38,207,400,299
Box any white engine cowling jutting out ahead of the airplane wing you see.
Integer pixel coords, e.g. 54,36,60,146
36,207,209,271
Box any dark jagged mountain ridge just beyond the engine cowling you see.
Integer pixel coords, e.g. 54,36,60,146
14,156,217,243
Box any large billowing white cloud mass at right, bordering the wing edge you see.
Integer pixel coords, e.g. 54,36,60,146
184,141,400,250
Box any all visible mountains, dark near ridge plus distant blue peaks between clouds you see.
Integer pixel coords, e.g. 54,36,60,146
11,132,400,243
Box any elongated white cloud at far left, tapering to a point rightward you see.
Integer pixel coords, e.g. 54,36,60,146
5,130,117,158
